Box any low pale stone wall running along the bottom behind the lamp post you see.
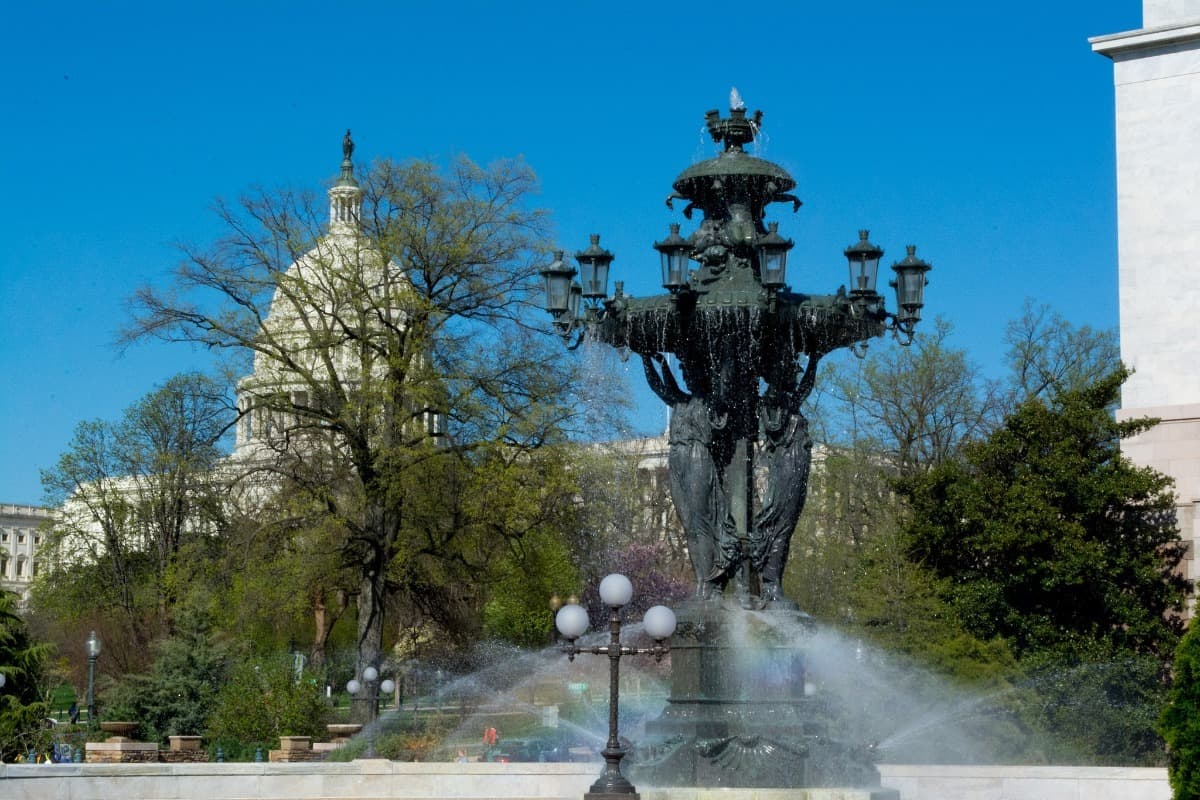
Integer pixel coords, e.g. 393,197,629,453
0,759,1171,800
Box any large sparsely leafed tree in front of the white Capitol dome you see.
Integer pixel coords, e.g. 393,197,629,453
128,153,590,705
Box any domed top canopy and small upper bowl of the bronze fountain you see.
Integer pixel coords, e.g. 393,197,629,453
673,108,796,221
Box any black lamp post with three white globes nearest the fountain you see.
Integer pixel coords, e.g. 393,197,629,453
554,575,676,800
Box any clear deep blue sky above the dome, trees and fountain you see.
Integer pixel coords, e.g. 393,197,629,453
0,0,1141,504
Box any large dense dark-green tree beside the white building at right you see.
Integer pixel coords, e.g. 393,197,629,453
901,368,1189,660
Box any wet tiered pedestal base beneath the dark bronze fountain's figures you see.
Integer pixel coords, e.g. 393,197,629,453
629,600,899,800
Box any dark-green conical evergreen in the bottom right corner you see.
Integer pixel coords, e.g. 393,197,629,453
1158,618,1200,800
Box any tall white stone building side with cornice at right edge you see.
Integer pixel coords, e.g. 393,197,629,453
1091,0,1200,587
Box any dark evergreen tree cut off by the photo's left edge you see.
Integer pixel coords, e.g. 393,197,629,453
0,590,50,762
